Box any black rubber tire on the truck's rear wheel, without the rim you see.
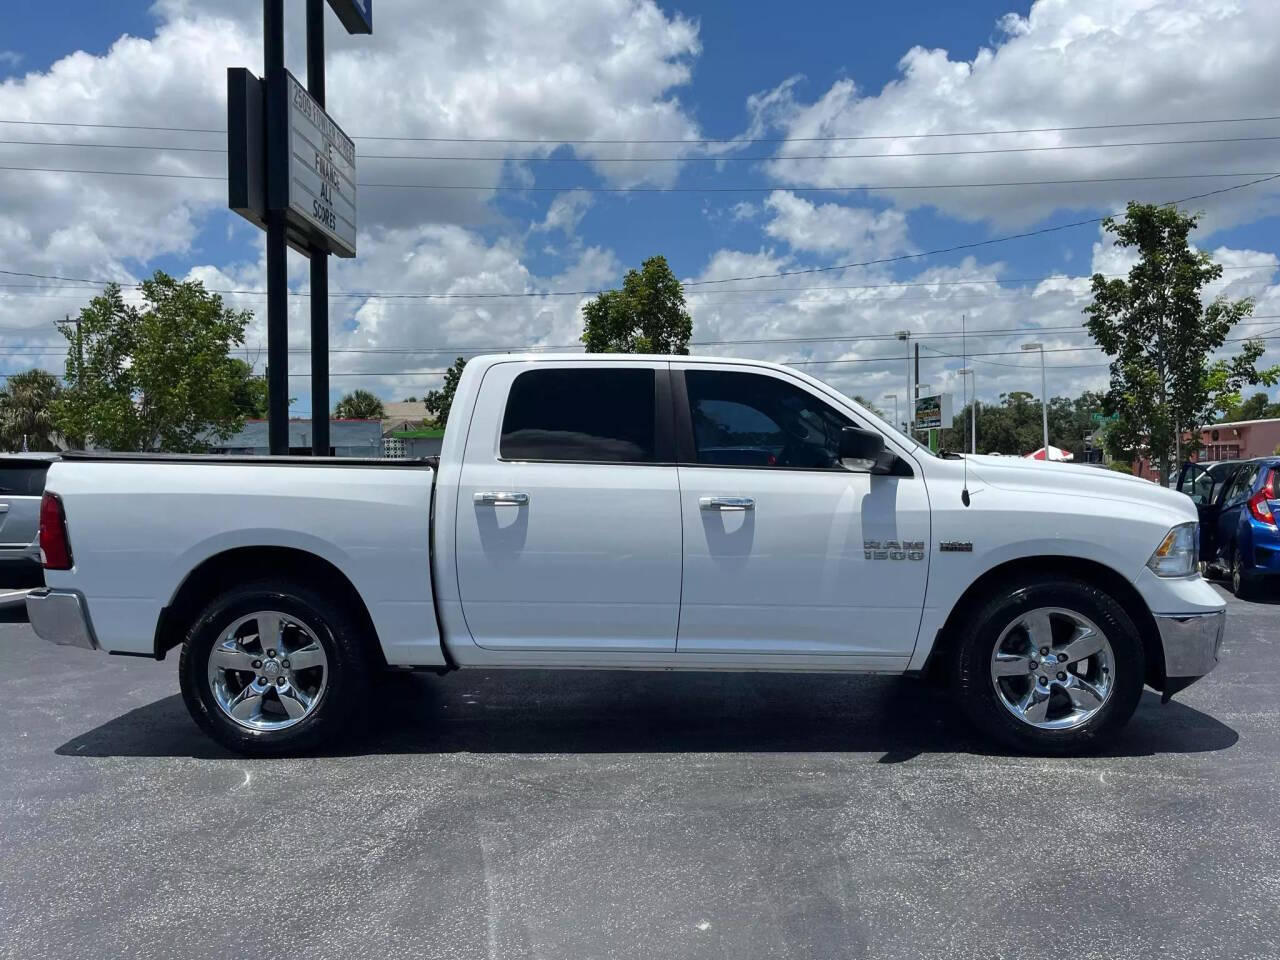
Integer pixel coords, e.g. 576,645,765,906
178,579,372,756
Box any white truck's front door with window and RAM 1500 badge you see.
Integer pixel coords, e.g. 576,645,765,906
673,364,929,657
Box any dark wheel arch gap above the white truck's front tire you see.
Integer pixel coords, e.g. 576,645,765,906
924,556,1165,690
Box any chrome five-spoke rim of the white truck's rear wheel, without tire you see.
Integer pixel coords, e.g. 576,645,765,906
209,611,329,732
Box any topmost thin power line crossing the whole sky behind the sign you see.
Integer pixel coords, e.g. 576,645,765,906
0,115,1280,146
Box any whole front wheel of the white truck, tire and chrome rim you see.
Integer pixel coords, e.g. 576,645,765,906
952,577,1146,755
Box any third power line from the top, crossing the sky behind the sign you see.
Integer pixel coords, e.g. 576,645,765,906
0,165,1280,195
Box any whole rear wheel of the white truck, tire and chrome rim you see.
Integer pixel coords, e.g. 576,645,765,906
178,580,370,756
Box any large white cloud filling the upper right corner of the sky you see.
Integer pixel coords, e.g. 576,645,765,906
749,0,1280,227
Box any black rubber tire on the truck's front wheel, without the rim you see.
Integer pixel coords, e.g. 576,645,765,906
950,577,1146,756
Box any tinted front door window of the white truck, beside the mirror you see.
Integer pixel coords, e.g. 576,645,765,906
685,370,854,470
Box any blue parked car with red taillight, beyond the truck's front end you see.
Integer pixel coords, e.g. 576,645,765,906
1178,457,1280,599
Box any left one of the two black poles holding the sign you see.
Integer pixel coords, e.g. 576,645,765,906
262,0,289,456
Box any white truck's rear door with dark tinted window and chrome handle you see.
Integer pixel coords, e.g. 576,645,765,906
456,360,681,653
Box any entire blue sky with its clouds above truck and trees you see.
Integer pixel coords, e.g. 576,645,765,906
0,0,1280,413
